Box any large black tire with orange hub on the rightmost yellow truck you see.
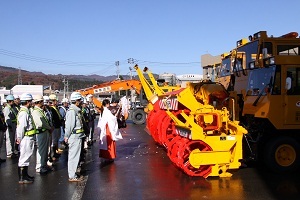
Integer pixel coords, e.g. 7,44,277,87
264,136,300,173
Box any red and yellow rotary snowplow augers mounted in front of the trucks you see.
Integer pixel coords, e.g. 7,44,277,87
134,65,247,178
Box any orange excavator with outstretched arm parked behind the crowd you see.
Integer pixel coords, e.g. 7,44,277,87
77,79,147,124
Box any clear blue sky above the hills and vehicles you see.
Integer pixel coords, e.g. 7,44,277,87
0,0,300,76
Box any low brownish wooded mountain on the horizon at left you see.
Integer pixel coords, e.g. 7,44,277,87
0,65,130,91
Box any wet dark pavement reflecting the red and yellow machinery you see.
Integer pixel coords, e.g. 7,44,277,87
0,119,300,200
